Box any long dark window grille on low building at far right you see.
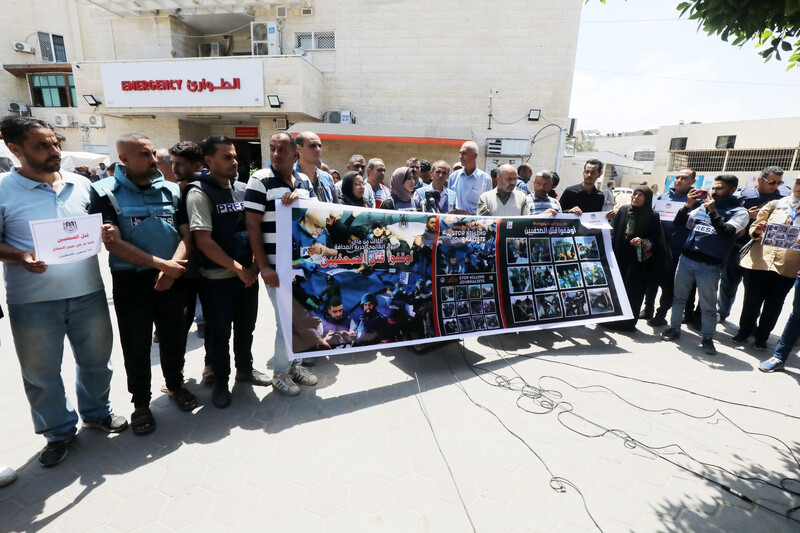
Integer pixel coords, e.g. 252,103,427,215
667,148,800,172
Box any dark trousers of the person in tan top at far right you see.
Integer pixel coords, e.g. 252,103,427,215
739,268,794,343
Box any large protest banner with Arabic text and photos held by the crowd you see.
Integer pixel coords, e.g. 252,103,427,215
276,200,632,357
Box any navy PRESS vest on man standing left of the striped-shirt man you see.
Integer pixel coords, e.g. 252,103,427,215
184,171,253,270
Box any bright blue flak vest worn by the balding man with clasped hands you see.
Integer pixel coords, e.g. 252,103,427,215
92,165,181,272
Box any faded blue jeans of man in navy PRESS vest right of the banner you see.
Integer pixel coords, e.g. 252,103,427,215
670,255,722,339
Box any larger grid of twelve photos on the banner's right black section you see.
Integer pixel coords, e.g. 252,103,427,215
505,236,614,324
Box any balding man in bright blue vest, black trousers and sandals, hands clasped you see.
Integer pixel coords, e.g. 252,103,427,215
90,133,197,435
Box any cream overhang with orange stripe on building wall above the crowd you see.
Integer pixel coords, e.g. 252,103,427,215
289,122,472,146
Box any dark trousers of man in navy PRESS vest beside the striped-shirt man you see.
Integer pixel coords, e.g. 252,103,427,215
200,276,258,383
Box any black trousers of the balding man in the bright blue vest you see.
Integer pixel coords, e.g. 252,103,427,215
111,270,188,407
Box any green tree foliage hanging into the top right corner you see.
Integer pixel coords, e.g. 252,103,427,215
585,0,800,70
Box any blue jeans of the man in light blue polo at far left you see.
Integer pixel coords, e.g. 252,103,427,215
8,291,113,442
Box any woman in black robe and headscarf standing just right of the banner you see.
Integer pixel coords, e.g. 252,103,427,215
610,185,672,331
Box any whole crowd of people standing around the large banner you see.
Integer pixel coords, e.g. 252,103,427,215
0,112,800,474
